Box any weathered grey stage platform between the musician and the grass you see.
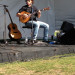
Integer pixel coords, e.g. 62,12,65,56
0,42,75,63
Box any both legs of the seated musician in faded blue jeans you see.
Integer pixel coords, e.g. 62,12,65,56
27,21,49,41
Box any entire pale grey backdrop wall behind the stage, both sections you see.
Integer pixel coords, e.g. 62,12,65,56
0,0,75,39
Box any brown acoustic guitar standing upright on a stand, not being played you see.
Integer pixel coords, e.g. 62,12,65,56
6,8,22,40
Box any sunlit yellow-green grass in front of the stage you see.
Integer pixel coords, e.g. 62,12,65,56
0,54,75,75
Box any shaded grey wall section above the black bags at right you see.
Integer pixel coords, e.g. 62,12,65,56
54,0,75,29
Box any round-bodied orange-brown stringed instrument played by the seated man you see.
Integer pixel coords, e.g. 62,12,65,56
19,7,50,23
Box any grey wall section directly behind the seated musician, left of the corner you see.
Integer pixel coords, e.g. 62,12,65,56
0,0,55,39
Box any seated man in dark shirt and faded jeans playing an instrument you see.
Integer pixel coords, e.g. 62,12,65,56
17,0,49,42
